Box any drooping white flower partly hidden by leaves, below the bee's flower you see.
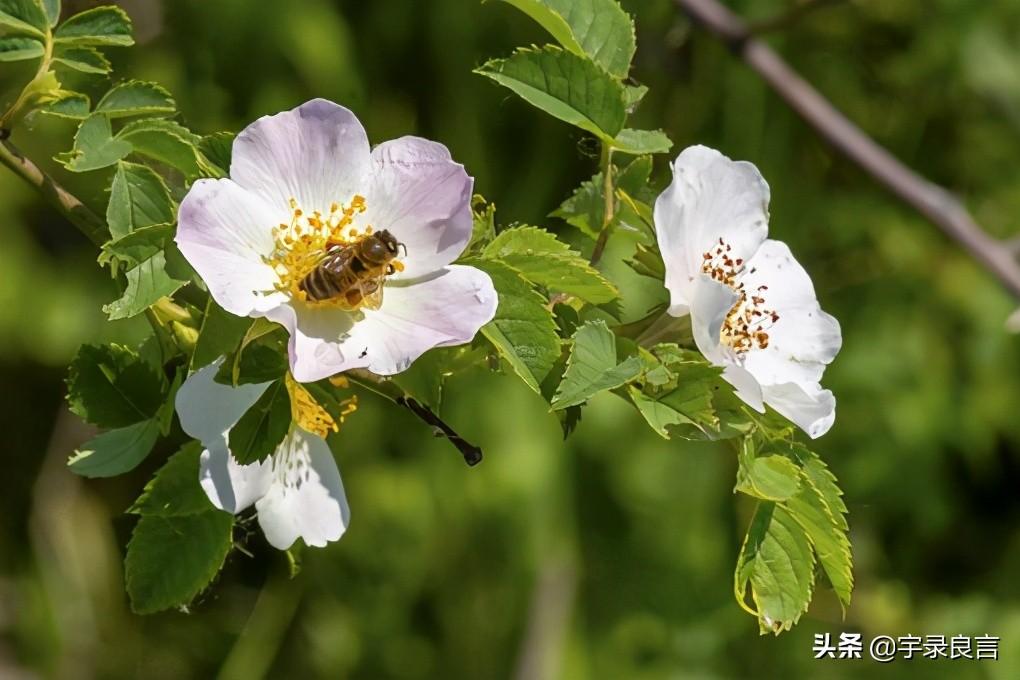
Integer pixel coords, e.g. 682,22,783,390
175,359,350,551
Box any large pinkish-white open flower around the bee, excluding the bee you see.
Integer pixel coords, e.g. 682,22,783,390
176,99,497,382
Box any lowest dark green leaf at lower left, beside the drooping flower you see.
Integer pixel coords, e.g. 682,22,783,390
124,509,234,614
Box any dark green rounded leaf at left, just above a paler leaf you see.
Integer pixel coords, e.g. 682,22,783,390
67,345,166,428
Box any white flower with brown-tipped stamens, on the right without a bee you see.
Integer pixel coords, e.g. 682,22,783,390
655,146,843,437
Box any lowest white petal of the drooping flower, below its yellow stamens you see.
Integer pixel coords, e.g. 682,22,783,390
255,427,351,551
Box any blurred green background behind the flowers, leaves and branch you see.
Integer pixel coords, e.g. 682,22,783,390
0,0,1020,680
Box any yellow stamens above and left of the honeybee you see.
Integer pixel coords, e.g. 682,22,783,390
265,196,372,301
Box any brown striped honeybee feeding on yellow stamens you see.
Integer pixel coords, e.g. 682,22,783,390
298,229,407,310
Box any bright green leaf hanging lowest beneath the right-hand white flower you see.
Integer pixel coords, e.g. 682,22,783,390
733,501,815,634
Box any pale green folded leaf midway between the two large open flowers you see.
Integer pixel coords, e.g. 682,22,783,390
552,321,642,410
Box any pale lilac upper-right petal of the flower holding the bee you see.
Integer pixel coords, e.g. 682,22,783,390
365,137,474,279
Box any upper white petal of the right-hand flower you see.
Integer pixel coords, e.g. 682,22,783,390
655,146,769,315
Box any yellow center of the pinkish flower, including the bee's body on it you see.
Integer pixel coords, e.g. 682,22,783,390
263,195,404,310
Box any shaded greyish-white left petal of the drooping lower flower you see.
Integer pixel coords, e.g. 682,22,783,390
174,358,270,449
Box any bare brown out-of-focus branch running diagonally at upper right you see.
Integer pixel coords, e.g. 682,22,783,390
673,0,1020,298
